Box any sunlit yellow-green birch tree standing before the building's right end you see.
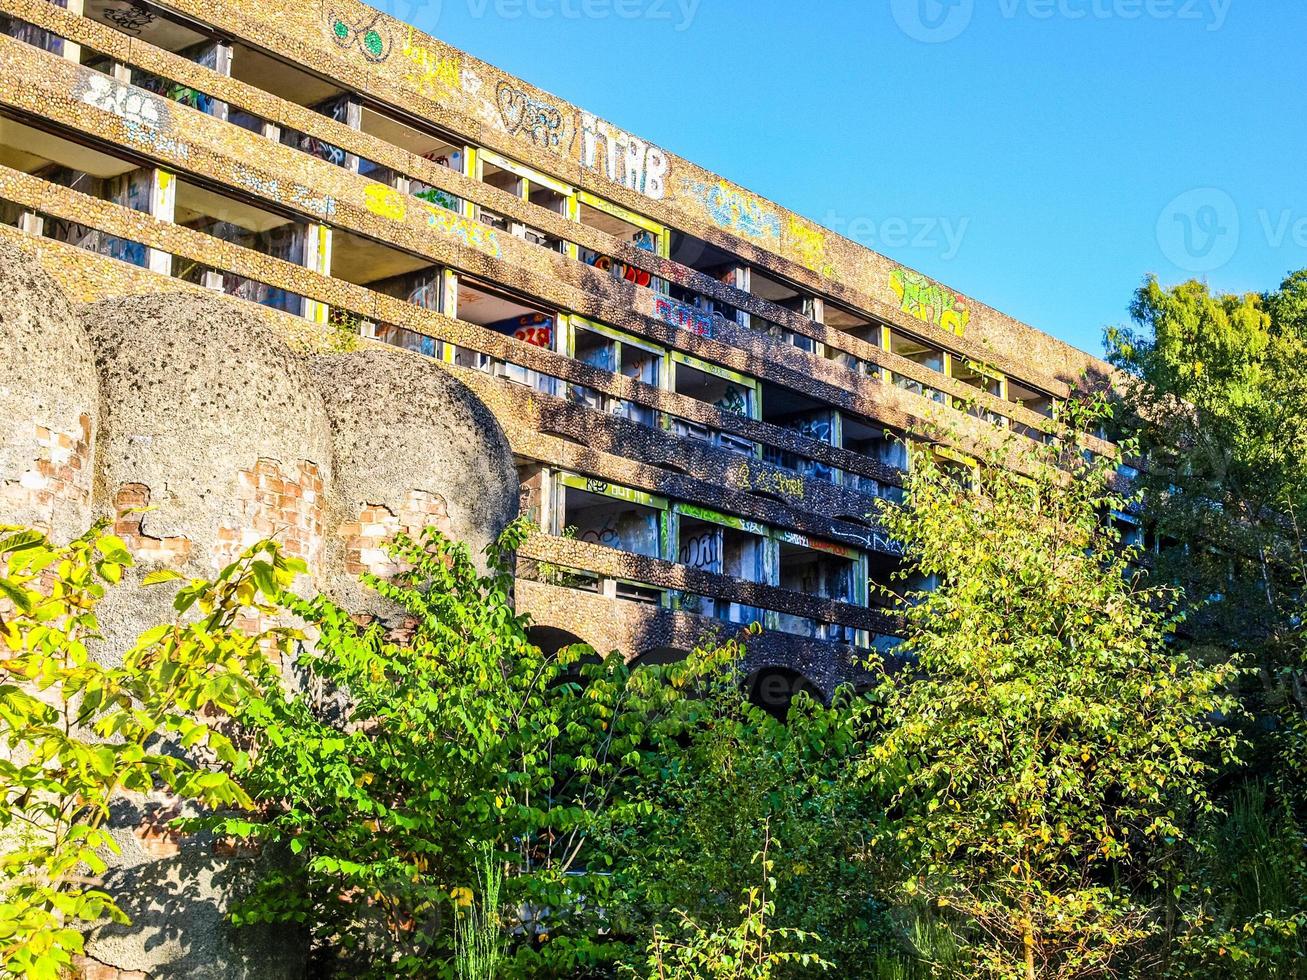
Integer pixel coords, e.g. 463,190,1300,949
861,408,1235,977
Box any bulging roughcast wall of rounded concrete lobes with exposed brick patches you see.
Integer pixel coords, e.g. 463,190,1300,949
0,239,518,980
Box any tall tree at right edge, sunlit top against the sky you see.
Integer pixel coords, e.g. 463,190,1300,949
1107,272,1307,717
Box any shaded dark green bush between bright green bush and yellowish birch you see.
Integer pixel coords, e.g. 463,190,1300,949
603,636,894,975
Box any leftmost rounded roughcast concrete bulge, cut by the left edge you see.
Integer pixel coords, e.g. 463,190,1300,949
0,242,99,538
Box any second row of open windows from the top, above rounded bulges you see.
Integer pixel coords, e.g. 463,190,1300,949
0,119,906,497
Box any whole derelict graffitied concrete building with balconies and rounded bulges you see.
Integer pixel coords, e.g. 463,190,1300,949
0,0,1111,980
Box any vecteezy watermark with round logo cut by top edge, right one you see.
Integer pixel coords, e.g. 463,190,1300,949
890,0,1234,44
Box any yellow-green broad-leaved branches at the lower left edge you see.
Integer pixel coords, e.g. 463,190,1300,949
0,524,302,977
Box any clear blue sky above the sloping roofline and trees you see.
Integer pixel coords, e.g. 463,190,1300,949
382,0,1307,353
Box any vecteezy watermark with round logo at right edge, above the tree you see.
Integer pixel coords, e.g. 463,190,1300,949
1157,187,1307,273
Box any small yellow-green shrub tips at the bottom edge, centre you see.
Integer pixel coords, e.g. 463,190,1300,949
623,830,831,980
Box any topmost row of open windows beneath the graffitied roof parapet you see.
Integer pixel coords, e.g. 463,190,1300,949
5,4,1056,438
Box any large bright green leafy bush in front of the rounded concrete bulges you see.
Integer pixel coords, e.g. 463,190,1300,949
203,524,648,977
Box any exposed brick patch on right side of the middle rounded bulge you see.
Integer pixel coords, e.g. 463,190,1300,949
214,459,323,567
